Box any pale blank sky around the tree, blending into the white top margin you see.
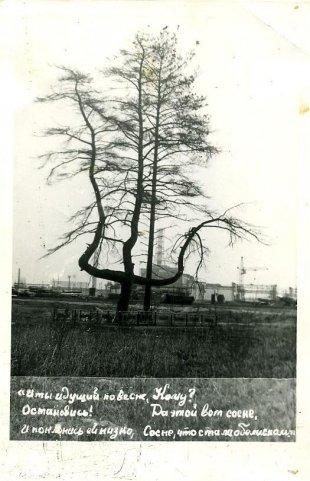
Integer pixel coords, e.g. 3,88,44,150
2,0,310,287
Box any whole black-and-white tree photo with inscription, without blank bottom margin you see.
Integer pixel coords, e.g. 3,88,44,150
7,1,309,441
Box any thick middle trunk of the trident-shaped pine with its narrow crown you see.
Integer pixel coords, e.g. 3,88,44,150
105,35,151,311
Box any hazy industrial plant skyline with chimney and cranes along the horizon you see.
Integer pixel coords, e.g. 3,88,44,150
13,229,297,303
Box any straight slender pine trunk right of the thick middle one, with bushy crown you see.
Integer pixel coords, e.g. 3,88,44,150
130,29,217,310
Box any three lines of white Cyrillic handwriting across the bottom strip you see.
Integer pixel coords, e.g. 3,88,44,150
15,383,295,440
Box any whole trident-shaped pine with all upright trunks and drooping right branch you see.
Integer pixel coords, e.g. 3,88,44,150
39,32,259,319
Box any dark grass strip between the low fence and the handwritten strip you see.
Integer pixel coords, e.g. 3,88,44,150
11,323,296,378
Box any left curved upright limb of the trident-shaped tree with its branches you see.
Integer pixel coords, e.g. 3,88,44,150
38,68,136,294
